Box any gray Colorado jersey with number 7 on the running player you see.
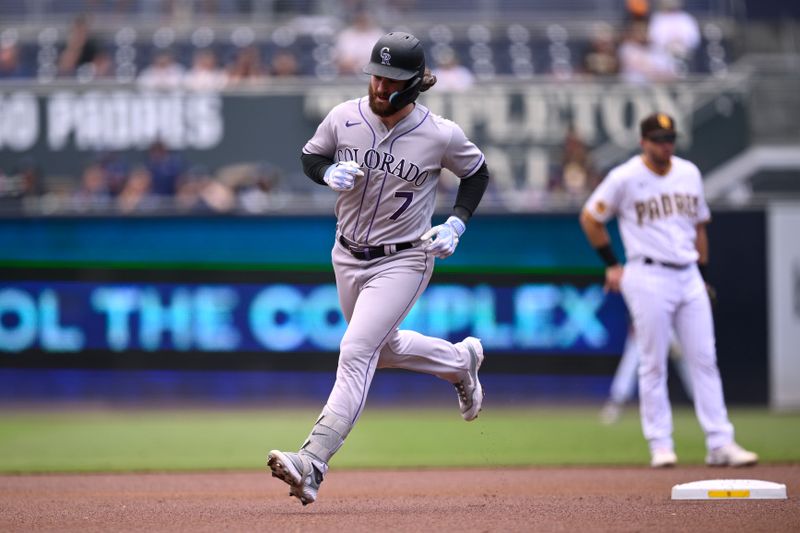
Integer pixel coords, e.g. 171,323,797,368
303,97,484,246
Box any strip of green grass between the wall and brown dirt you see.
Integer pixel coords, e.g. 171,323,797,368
0,407,800,473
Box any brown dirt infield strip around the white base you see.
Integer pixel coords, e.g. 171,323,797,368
0,465,800,533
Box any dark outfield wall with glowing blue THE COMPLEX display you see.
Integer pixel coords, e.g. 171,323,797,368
0,211,768,403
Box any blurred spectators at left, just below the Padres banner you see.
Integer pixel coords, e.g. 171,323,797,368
0,142,285,214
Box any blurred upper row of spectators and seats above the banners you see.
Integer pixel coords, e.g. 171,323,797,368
0,0,712,85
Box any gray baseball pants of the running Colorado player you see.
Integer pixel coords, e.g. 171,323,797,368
323,242,476,427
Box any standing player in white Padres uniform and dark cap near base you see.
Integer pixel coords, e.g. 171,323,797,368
580,113,758,467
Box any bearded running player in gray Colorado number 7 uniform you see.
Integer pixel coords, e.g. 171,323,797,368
267,32,489,505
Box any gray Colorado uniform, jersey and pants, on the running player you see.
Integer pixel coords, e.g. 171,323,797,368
303,93,484,450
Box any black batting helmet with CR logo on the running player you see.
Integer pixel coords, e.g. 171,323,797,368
363,31,425,109
